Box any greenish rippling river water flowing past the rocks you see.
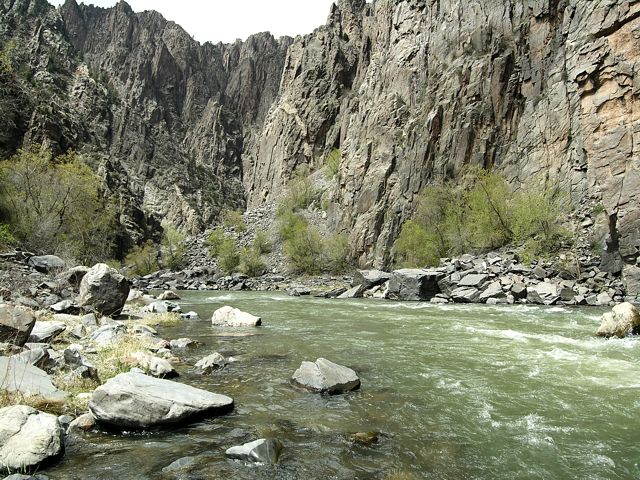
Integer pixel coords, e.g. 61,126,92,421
45,292,640,480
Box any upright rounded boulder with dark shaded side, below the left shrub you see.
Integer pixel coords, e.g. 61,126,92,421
78,263,129,316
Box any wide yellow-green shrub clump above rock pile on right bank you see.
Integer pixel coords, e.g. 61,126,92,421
394,168,570,267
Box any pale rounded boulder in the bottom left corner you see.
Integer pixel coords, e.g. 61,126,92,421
0,405,64,472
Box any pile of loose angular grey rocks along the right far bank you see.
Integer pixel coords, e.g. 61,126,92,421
348,253,635,306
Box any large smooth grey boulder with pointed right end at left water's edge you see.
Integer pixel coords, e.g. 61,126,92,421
89,373,233,428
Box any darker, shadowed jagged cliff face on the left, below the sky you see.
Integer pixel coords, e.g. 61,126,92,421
0,0,291,248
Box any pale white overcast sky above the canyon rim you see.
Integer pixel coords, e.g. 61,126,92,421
49,0,333,43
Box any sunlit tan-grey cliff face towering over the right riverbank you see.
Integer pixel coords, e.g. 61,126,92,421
245,0,640,276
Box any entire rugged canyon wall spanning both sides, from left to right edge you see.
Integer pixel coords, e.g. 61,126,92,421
0,0,640,282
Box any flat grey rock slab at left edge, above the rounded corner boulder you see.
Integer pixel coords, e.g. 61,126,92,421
0,357,67,402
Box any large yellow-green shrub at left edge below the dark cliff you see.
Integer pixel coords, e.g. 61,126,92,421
0,149,115,264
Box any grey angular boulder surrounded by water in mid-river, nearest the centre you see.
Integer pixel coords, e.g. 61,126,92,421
291,358,360,395
